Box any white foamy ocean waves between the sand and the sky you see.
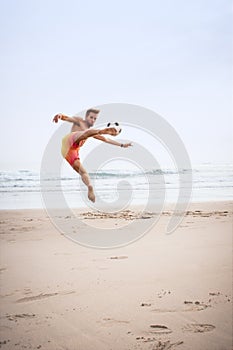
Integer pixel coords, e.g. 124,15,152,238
0,164,233,210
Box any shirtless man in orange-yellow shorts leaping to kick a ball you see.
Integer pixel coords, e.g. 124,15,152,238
53,108,132,202
